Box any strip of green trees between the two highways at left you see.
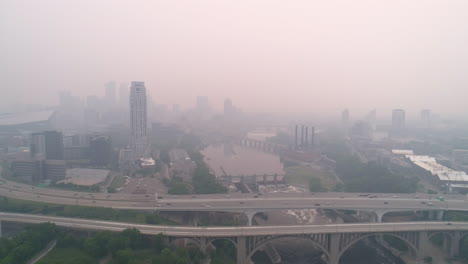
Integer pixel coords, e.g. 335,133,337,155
0,197,171,224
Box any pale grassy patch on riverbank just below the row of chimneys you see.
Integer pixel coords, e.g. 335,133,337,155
286,166,336,190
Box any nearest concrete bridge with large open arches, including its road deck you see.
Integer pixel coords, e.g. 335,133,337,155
0,213,468,264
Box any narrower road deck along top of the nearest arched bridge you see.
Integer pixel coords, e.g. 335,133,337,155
0,213,468,237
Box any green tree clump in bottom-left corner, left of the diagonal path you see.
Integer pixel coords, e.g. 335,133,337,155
0,223,57,264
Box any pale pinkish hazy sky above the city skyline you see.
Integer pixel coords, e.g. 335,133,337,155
0,0,468,115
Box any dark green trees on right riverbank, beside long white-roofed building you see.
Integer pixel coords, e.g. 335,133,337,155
336,156,418,193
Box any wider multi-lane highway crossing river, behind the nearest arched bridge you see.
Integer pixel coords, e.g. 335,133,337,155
0,176,468,212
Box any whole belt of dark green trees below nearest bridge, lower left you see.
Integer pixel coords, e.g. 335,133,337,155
0,223,236,264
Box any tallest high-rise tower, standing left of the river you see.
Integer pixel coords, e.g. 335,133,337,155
130,82,149,159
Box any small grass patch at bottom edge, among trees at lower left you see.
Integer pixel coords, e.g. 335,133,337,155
36,247,99,264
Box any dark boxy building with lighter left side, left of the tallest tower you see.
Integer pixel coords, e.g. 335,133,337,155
31,131,64,160
